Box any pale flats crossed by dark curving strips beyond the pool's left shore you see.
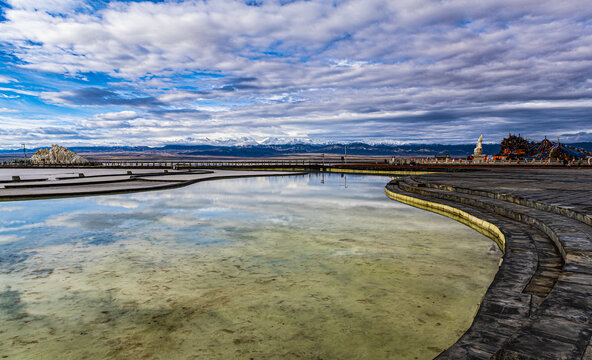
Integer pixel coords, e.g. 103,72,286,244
0,169,299,201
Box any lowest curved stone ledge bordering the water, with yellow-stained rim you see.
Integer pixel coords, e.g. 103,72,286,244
385,180,538,359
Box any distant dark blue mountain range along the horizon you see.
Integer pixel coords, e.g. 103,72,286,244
0,142,592,157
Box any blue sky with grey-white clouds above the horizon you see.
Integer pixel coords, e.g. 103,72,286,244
0,0,592,148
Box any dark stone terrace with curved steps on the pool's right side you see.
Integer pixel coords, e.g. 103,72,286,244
387,169,592,360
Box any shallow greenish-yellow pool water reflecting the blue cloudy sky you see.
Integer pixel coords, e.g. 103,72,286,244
0,175,501,359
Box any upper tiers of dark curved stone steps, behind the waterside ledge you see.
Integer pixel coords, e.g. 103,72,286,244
388,180,592,360
